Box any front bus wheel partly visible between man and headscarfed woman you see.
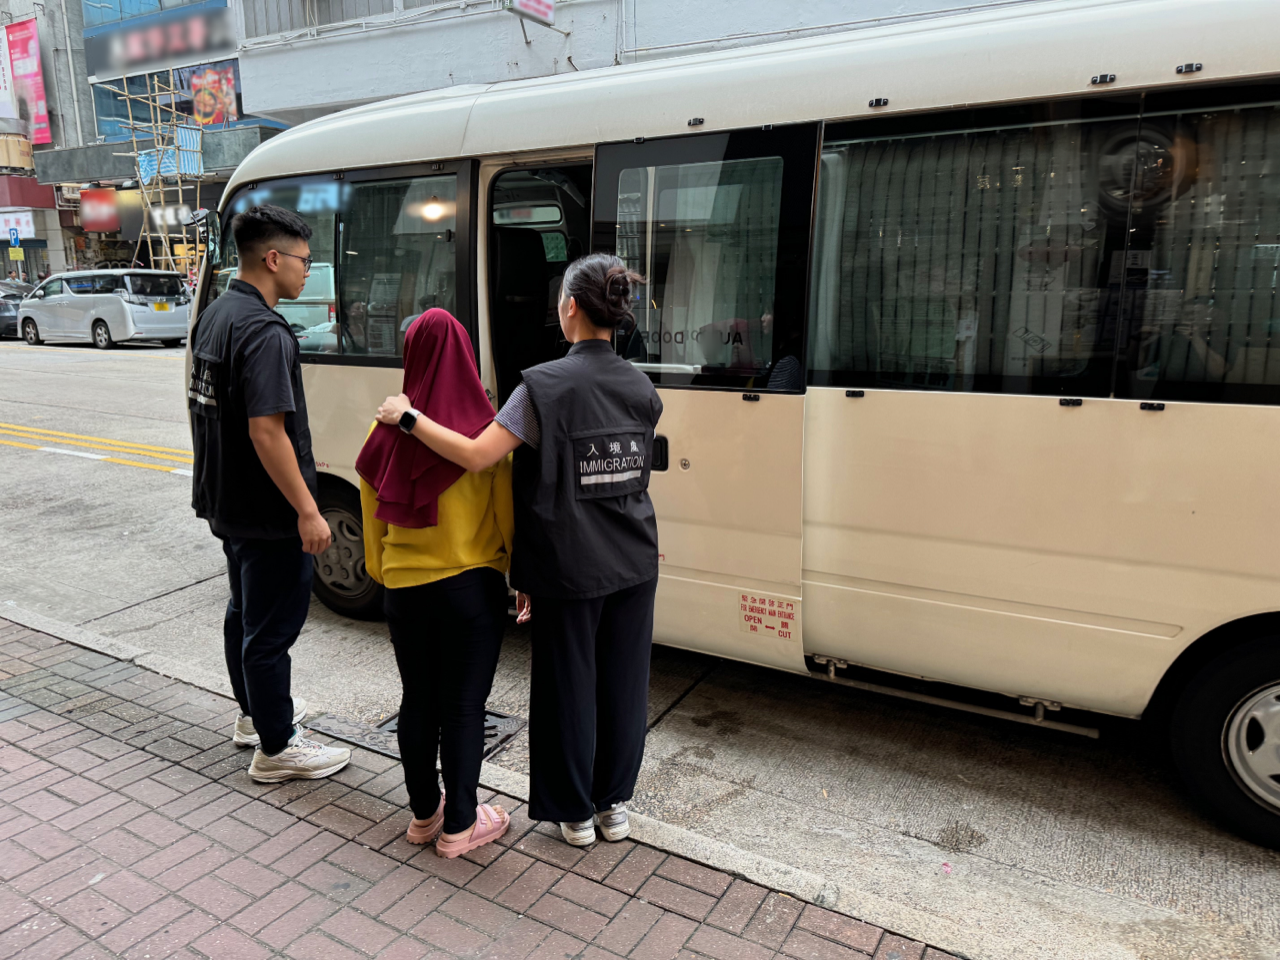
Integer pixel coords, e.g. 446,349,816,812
312,479,383,620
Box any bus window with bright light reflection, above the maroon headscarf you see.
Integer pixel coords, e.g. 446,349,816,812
338,174,458,357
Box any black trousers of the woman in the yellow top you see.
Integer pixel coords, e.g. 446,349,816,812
385,567,507,833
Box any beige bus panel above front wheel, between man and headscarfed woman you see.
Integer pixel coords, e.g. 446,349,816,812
302,364,404,486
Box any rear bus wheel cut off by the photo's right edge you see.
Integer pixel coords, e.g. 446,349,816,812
1170,636,1280,850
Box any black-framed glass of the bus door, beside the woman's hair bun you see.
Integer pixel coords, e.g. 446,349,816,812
595,125,817,389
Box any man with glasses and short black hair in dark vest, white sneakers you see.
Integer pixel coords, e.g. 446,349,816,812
187,206,351,783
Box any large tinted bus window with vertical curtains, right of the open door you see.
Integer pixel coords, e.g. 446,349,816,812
809,105,1138,397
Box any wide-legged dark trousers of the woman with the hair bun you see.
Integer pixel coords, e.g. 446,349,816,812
529,577,658,820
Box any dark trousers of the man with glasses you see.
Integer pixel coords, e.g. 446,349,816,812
223,536,314,754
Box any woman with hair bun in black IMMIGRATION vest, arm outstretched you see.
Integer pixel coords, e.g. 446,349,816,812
378,253,662,846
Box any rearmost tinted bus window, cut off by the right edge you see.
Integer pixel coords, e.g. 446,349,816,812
1116,104,1280,403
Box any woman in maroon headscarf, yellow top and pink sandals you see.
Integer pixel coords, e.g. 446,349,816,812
356,308,513,858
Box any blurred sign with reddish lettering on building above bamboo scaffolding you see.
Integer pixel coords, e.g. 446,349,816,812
84,6,236,81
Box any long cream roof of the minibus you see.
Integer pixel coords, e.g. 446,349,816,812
230,0,1280,202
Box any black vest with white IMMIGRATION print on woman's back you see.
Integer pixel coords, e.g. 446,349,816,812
511,340,662,601
